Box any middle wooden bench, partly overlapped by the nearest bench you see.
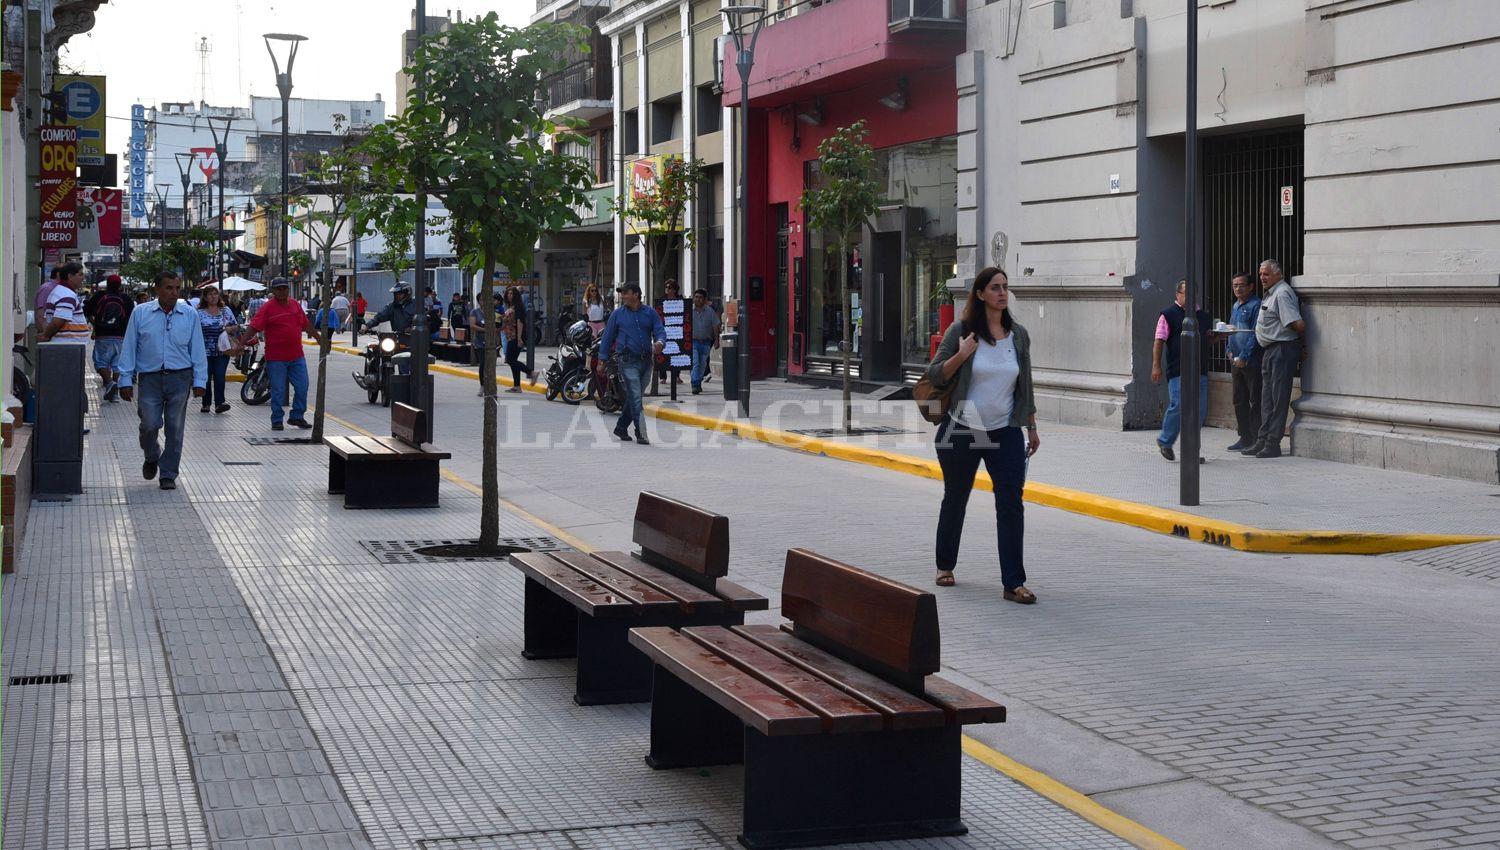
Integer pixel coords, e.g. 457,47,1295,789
510,493,770,705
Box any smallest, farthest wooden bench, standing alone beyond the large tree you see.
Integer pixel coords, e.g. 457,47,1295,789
323,402,453,508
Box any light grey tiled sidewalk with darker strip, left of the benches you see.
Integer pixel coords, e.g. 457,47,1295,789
3,382,1125,850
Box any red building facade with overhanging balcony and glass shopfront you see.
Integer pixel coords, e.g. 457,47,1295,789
723,0,965,384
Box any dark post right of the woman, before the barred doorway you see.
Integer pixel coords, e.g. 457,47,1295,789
1178,0,1209,505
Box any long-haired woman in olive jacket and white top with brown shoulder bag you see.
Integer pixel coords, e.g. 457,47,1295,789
927,268,1041,606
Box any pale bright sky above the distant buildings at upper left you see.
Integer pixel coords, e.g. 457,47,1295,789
62,0,536,171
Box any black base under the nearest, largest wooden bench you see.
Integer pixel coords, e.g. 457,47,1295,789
647,667,968,850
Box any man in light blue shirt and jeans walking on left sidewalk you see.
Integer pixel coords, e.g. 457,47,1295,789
119,271,209,490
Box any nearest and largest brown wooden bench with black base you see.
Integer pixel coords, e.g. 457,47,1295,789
630,549,1005,849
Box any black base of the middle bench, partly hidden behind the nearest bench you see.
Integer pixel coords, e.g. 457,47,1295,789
521,576,744,706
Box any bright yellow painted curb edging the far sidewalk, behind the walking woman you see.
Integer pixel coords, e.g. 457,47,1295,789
303,340,1500,555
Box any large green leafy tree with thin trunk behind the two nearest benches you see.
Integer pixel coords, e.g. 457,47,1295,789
363,12,593,550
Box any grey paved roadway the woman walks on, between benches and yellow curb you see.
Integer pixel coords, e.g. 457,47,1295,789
307,349,1500,849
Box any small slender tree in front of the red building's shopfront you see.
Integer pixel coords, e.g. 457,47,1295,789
801,120,881,433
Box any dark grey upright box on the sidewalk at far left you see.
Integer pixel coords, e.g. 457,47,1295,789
32,342,87,495
